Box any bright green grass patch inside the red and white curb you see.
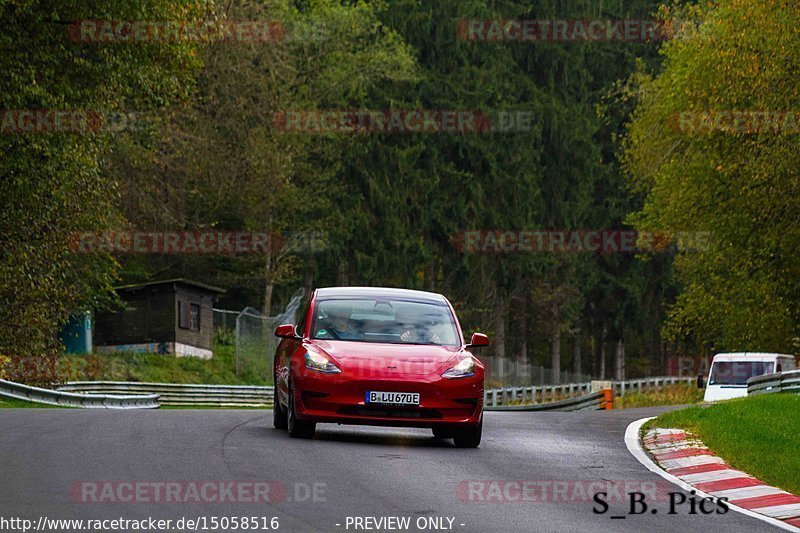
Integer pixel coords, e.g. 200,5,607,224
642,393,800,494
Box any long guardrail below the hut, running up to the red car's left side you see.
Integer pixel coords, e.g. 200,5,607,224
59,381,274,407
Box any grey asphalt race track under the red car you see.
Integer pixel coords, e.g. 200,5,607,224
0,408,771,533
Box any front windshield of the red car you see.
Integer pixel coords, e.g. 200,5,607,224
311,298,459,346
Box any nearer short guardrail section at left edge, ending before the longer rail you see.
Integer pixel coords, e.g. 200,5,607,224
0,379,159,409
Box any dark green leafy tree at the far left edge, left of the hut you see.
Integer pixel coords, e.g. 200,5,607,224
0,0,209,366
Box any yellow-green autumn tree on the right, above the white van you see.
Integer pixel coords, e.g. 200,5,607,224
625,0,800,351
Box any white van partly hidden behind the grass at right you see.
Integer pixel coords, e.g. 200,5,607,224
703,352,797,402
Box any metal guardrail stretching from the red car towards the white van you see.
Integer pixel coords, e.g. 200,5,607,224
483,376,697,407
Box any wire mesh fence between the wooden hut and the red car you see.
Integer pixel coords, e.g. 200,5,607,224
214,288,305,383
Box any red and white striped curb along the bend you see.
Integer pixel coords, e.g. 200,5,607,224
625,418,800,533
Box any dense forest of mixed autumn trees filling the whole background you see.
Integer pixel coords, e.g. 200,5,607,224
0,0,800,377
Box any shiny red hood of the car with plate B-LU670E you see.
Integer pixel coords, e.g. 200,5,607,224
309,340,466,376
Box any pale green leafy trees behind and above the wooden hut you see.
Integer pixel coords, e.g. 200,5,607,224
113,0,415,314
